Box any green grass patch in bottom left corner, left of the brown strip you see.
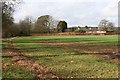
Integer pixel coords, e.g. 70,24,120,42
2,66,35,79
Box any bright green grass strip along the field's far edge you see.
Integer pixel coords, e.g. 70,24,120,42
10,35,118,44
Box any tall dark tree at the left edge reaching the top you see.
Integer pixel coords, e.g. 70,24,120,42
2,0,21,37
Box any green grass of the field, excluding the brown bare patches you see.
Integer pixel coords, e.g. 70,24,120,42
3,35,118,78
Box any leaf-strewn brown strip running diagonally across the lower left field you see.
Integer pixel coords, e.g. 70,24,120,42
2,43,58,80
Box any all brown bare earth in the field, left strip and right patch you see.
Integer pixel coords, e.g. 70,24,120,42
2,40,120,80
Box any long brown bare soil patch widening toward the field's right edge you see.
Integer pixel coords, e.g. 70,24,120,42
38,40,120,63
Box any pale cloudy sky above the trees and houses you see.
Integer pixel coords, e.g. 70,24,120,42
14,0,119,27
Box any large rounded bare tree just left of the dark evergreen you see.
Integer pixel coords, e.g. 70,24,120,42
34,15,56,33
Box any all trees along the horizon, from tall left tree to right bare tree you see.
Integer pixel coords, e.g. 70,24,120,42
2,0,114,37
